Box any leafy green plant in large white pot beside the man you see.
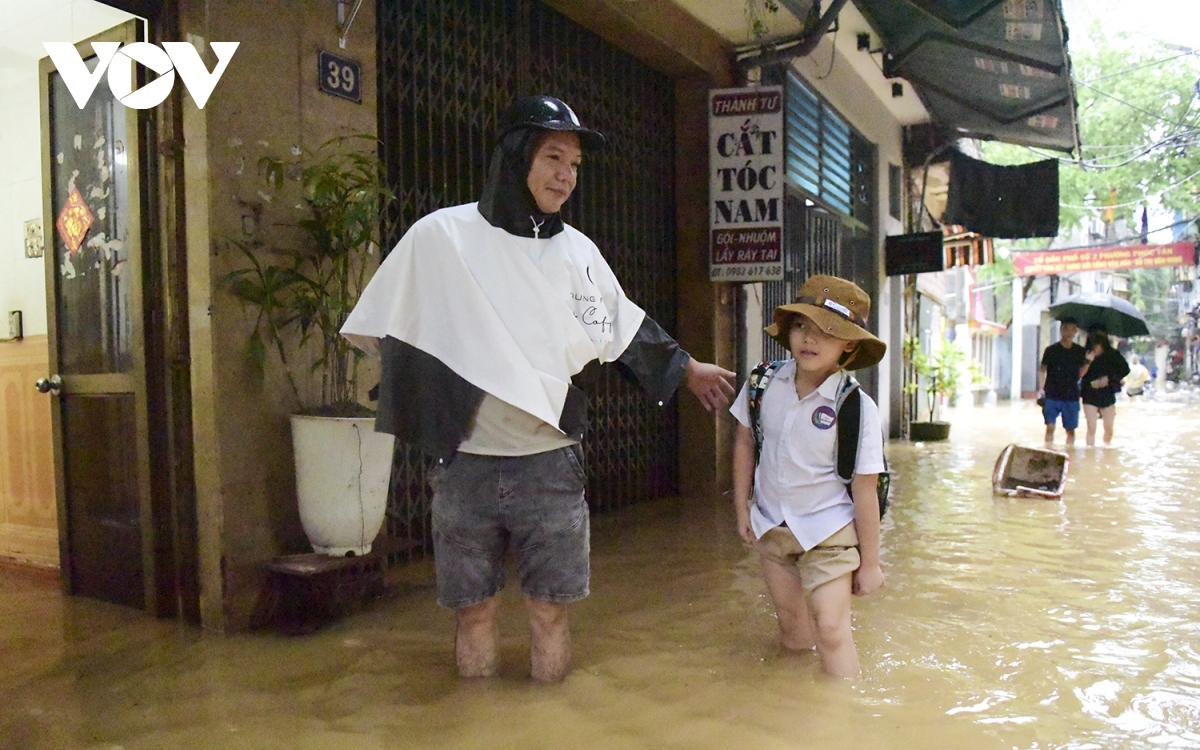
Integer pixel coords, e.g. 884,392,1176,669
222,136,392,556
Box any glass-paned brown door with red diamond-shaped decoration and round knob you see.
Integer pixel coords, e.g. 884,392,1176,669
41,22,155,611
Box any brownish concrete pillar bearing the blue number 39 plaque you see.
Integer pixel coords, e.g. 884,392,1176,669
176,0,377,631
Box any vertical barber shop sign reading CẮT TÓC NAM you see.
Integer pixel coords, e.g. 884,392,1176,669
708,86,784,282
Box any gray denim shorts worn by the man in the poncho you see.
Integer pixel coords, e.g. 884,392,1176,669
430,448,590,610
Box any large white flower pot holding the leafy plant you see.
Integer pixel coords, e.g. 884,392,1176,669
292,415,395,557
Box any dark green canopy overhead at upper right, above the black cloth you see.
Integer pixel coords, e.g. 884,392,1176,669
856,0,1079,152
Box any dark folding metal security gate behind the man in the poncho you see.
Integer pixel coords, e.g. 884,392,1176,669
378,0,678,548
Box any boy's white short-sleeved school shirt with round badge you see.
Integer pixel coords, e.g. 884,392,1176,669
730,360,884,550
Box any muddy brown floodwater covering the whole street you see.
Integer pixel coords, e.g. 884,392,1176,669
0,402,1200,750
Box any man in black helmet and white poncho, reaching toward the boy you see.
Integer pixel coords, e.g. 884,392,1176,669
342,96,733,682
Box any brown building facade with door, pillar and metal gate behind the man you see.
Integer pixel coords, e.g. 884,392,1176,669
0,0,1070,631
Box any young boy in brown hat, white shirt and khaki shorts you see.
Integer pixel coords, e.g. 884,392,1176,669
731,276,887,677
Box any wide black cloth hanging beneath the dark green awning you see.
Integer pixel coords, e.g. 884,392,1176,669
942,149,1058,240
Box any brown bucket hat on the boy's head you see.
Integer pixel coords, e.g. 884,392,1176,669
766,276,888,370
